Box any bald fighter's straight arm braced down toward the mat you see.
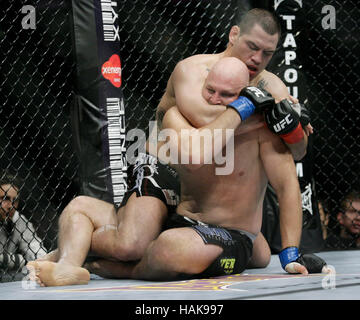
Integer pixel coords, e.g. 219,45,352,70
260,128,302,248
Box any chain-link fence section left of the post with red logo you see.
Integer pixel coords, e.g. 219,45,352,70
0,0,78,281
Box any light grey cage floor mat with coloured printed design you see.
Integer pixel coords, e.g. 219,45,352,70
0,250,360,301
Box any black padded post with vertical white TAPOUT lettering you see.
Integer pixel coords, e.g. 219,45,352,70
269,0,322,251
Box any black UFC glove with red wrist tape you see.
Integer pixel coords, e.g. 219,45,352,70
265,99,304,144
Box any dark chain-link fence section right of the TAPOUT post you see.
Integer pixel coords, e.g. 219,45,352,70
304,0,360,249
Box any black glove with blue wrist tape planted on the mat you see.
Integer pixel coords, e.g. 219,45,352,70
279,247,326,273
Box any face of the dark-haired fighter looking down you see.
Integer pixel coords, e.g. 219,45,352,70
229,24,279,80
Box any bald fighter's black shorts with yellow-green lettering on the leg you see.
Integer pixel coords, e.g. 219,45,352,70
165,213,255,278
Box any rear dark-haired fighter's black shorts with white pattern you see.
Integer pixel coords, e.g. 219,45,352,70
120,153,180,211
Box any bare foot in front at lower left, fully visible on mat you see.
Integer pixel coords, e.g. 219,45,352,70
26,261,90,287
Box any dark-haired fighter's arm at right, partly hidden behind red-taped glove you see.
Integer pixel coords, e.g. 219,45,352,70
257,71,308,160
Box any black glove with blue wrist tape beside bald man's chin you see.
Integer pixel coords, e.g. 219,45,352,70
227,87,275,121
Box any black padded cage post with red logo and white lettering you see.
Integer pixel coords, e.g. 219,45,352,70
72,0,126,205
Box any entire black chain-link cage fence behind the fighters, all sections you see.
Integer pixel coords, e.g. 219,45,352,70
0,0,360,279
